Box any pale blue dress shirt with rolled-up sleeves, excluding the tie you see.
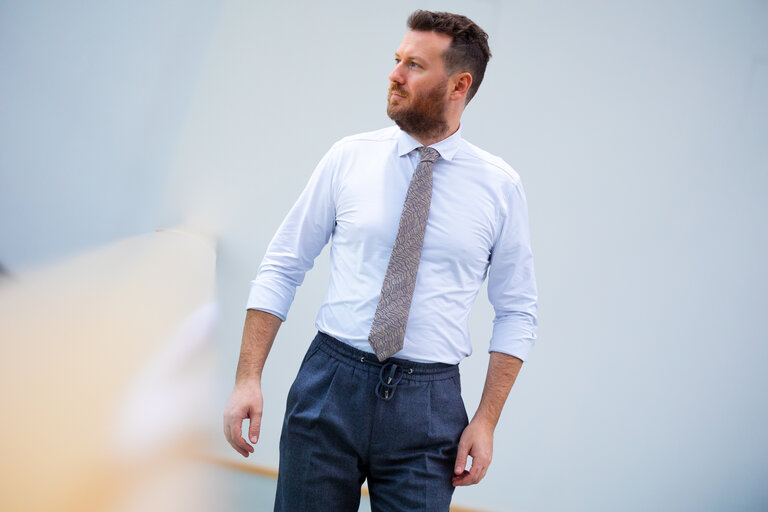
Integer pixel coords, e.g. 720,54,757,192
247,126,536,364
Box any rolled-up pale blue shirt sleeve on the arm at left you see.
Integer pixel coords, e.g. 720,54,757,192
247,148,336,320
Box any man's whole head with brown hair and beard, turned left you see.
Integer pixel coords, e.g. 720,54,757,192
387,11,491,142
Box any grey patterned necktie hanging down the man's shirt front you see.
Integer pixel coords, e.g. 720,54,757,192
368,147,440,361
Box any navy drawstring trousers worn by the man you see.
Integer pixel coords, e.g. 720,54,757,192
275,333,467,512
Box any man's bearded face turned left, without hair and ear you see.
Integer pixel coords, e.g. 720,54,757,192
387,30,451,136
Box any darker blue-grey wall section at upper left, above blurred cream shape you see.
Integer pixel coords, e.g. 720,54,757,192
0,0,219,271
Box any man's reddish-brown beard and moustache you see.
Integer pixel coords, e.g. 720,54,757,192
387,79,448,138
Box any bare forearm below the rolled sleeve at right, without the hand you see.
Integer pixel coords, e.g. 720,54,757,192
472,352,523,428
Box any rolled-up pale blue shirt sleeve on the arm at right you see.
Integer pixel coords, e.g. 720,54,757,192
488,180,537,361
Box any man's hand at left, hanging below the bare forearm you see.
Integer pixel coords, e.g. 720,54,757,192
224,382,263,457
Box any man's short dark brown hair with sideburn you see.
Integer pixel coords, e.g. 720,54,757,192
408,10,491,103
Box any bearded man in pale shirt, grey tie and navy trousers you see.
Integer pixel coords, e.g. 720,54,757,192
224,11,536,512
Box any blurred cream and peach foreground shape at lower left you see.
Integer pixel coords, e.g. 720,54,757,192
0,230,218,511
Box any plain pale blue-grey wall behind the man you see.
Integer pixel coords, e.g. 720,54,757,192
0,0,768,511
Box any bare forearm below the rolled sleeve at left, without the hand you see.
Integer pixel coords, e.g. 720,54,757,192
235,309,282,384
